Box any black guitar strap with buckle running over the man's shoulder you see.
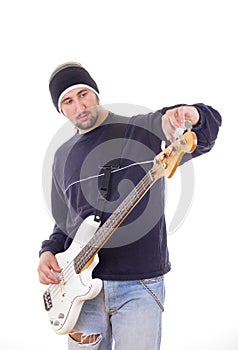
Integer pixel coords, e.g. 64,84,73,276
94,115,129,222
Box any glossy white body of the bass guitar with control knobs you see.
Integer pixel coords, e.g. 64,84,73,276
44,216,102,334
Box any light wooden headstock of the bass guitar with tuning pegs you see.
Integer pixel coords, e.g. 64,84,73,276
152,131,197,180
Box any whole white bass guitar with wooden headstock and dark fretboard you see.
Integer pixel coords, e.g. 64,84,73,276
43,131,197,334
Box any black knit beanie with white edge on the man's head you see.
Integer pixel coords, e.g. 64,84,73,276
49,63,99,112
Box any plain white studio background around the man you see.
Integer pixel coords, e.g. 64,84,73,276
0,0,238,350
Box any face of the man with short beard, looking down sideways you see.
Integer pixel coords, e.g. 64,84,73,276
60,88,98,131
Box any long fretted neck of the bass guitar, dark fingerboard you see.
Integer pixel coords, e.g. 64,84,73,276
74,169,157,273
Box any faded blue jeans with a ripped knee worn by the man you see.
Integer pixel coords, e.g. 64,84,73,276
68,276,165,350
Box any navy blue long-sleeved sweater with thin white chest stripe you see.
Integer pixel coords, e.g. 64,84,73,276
40,103,221,280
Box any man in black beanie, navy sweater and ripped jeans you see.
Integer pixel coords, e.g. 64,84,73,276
38,62,221,350
